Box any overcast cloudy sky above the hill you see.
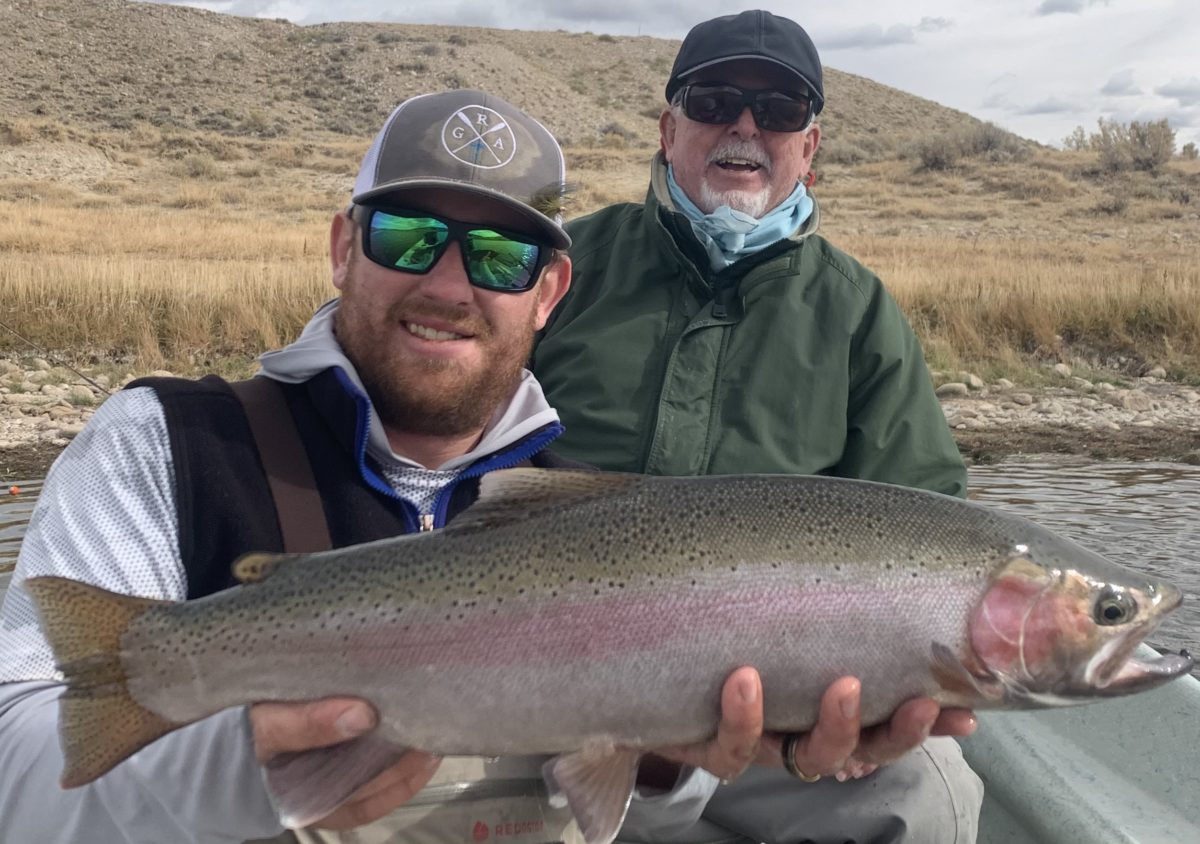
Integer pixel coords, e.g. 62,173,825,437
156,0,1200,146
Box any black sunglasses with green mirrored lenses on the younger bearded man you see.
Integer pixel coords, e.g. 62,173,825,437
350,205,554,293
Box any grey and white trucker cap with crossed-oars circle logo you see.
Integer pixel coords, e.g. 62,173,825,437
352,90,571,249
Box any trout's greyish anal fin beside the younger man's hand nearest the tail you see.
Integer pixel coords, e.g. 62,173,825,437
264,732,407,830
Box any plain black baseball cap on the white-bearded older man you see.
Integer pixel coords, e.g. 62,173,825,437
667,10,824,114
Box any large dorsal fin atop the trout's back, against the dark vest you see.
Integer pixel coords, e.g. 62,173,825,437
446,468,646,531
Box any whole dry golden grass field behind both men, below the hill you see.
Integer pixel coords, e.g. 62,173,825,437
0,121,1200,383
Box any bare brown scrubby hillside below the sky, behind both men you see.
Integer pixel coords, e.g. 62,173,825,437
0,0,974,152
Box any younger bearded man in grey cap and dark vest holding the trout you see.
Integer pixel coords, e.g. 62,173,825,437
0,90,762,844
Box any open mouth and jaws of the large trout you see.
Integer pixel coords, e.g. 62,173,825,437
1084,587,1194,696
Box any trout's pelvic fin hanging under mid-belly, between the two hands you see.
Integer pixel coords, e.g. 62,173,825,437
541,748,642,844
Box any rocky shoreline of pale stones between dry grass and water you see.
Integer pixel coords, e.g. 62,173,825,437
0,359,1200,484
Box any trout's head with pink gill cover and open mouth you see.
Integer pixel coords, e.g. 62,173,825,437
970,535,1192,707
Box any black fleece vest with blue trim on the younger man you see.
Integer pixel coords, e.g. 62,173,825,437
130,369,584,599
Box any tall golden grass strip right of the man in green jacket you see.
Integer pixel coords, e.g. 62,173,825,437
844,229,1200,378
